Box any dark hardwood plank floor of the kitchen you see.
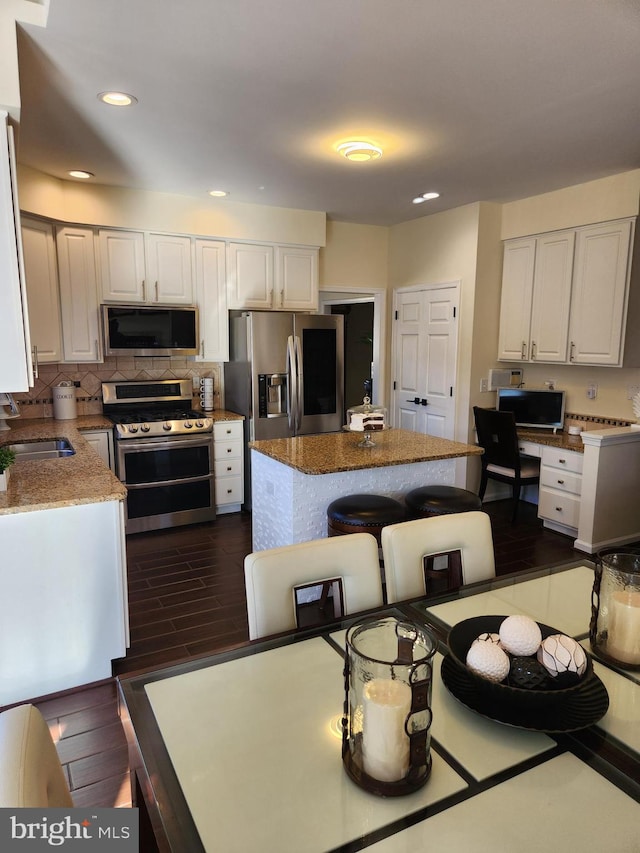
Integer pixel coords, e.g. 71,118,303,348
30,501,584,807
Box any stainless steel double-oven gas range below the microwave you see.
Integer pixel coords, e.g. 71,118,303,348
102,379,215,533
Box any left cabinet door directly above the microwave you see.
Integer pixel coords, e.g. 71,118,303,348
98,229,145,303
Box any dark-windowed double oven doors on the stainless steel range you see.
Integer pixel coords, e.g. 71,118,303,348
116,433,215,533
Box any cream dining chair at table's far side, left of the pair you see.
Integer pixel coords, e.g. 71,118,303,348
244,533,383,640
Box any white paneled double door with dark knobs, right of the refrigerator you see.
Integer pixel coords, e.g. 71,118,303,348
392,284,459,438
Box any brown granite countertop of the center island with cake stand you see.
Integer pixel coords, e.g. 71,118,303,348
249,429,482,474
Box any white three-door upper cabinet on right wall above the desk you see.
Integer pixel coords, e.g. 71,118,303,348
498,220,634,367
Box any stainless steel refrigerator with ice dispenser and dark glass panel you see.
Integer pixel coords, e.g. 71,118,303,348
224,311,345,508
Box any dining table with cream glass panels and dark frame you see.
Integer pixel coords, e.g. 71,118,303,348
120,564,640,853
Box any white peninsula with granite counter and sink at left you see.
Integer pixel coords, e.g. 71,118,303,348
0,416,129,706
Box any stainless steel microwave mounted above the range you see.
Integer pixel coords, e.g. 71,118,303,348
102,305,199,356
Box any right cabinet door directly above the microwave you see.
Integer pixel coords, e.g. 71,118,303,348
146,234,193,305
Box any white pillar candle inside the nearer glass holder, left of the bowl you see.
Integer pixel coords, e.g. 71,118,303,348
362,678,411,782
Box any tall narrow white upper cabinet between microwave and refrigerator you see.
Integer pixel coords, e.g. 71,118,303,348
194,239,229,361
